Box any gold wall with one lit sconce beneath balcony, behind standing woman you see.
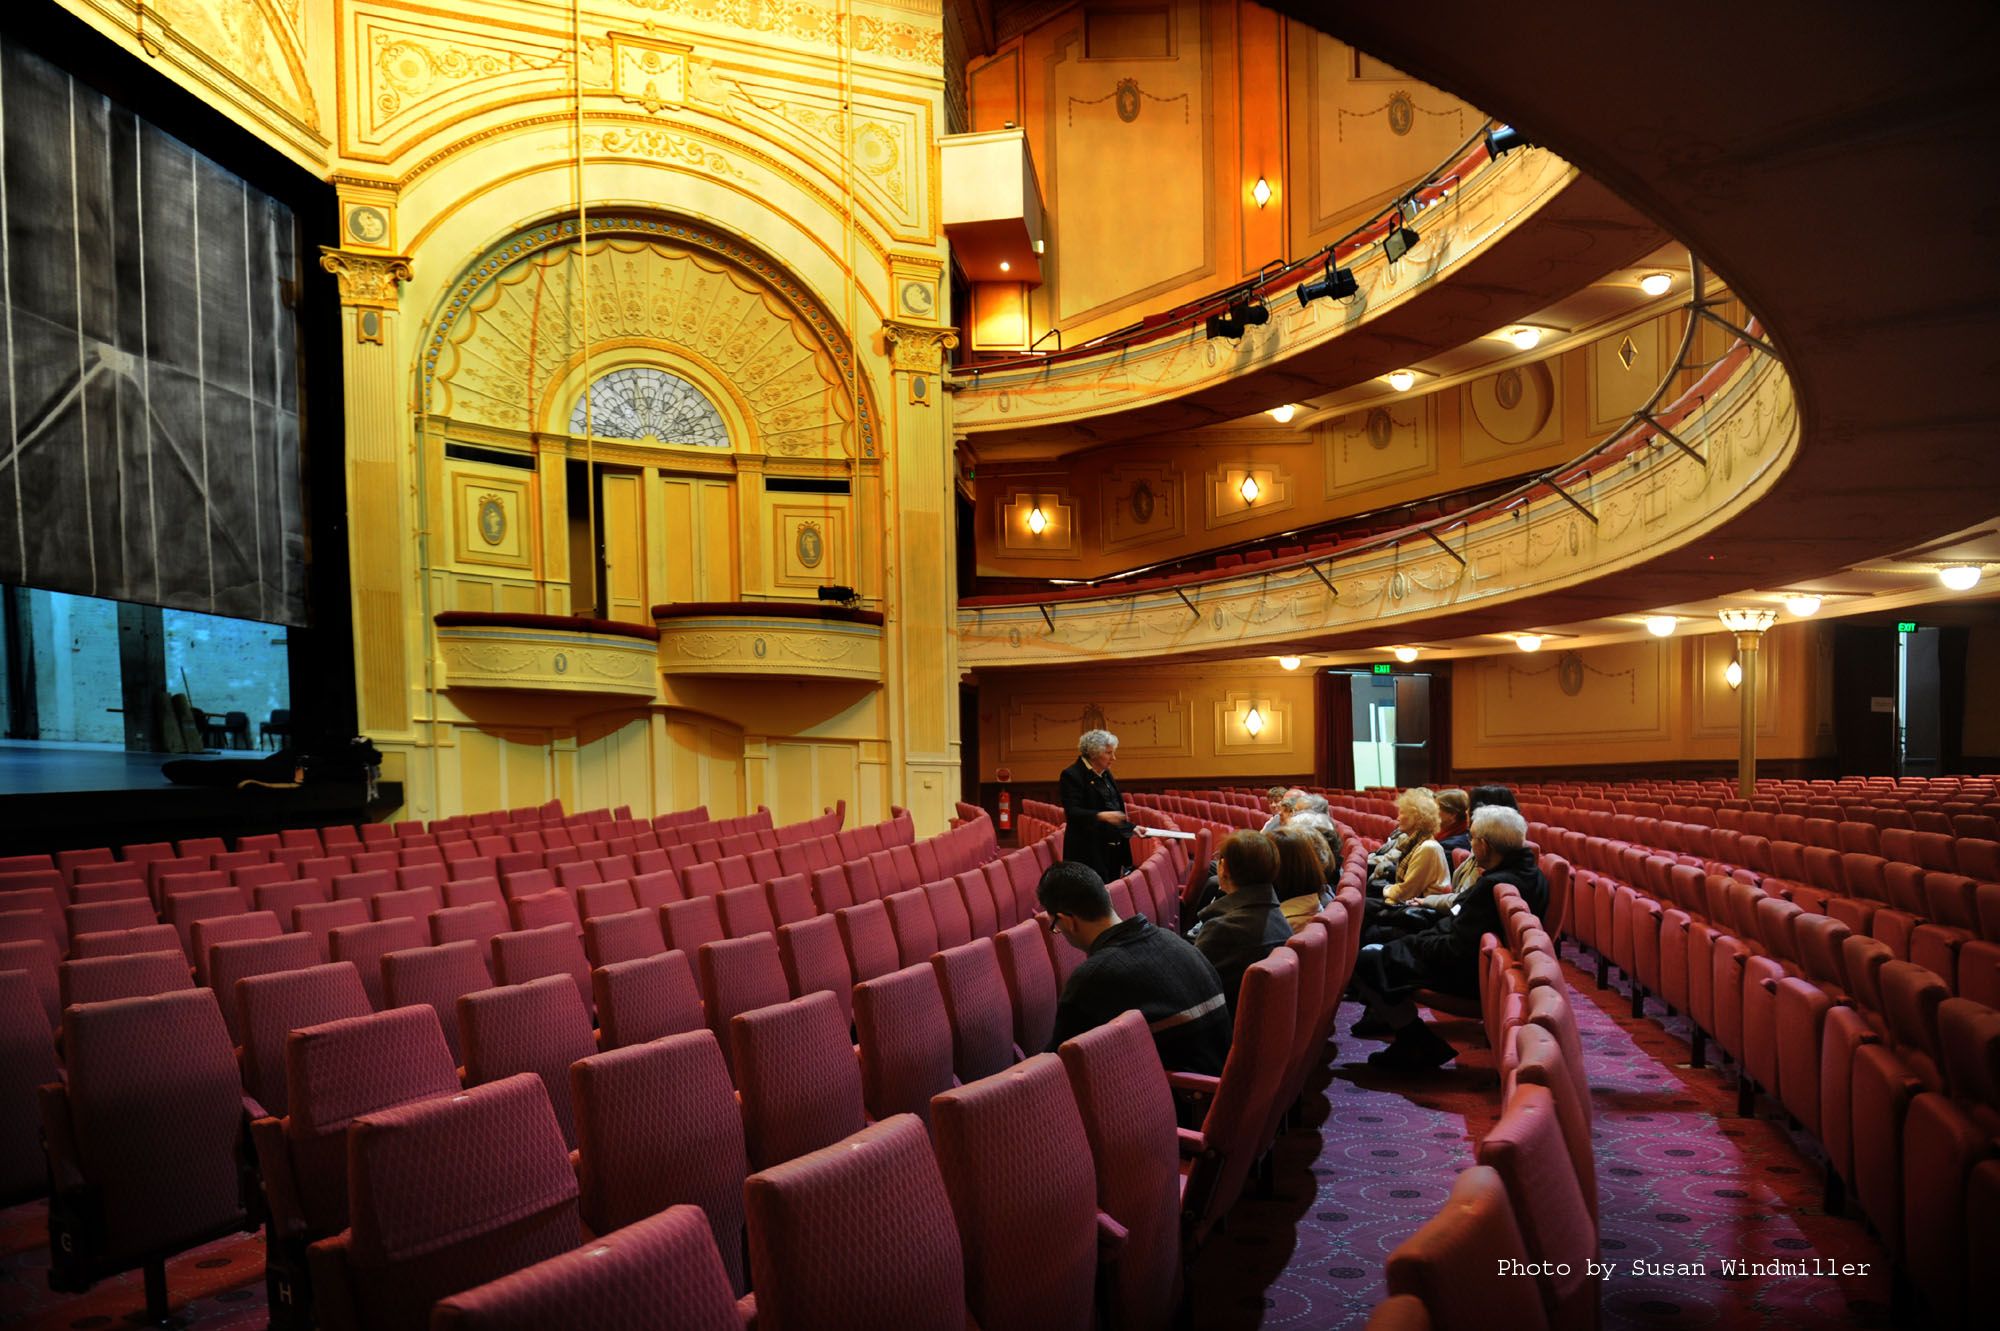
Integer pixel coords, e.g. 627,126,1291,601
980,658,1314,781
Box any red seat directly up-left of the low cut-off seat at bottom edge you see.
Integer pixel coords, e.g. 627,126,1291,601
310,1075,584,1331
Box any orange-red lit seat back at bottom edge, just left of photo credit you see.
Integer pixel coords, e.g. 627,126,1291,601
1388,1165,1548,1331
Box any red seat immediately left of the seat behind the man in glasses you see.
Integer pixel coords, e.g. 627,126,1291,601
930,1053,1098,1331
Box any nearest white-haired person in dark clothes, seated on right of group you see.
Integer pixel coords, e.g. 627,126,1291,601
1352,805,1548,1071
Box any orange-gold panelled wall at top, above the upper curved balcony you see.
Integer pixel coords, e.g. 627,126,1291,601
966,0,1484,352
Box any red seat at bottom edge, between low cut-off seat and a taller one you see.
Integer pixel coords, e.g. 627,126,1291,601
744,1115,972,1331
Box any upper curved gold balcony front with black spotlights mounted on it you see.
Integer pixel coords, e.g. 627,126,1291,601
952,134,1666,456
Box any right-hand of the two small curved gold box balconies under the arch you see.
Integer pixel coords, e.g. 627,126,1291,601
652,602,882,683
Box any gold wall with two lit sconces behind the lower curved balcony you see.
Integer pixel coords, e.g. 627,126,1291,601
976,312,1684,578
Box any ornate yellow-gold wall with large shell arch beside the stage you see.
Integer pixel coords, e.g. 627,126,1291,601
64,0,958,831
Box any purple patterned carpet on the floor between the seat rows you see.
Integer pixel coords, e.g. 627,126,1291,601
0,947,1890,1331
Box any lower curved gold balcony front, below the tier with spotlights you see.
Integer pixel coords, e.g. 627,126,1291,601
958,268,1800,667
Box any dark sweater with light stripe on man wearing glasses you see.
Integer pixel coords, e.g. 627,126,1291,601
1048,915,1232,1075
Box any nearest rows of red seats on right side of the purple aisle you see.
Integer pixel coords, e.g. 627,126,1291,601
1542,827,2000,1325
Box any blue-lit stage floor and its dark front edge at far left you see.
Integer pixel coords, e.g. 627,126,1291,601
0,739,402,855
